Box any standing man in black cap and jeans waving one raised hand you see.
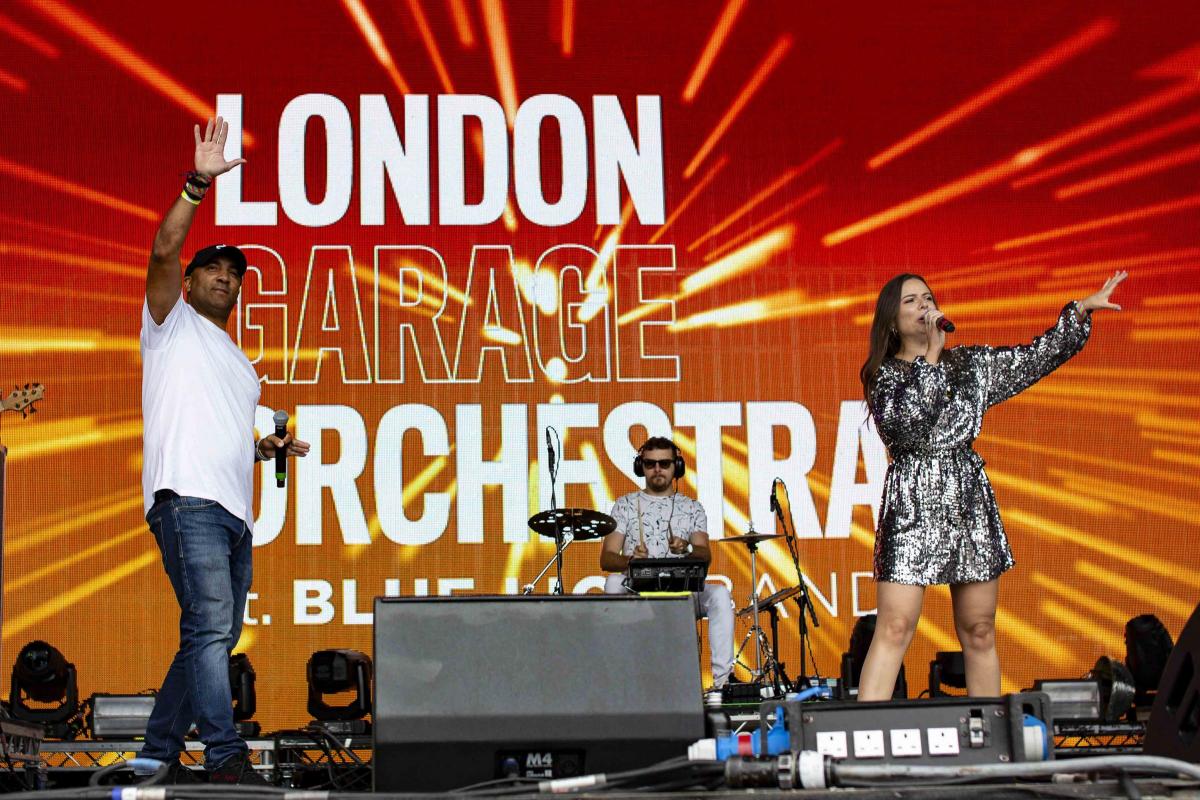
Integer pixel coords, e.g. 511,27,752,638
142,118,308,784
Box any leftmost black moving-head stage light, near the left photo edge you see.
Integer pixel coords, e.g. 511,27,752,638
8,639,79,739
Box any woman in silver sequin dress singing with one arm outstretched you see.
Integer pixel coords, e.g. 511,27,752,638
858,272,1126,700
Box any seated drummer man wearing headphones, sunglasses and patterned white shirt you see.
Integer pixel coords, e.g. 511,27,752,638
600,437,733,688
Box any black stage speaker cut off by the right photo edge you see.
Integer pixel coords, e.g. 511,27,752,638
1142,606,1200,764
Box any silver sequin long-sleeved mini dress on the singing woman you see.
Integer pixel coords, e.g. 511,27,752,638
871,303,1092,587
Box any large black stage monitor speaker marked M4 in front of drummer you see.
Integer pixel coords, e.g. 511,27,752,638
373,595,704,792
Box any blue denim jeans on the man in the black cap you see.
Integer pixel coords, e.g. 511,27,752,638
142,493,253,769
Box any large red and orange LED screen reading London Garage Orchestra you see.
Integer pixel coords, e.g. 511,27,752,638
0,0,1200,728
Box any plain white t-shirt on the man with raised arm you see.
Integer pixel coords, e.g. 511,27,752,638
142,296,260,528
